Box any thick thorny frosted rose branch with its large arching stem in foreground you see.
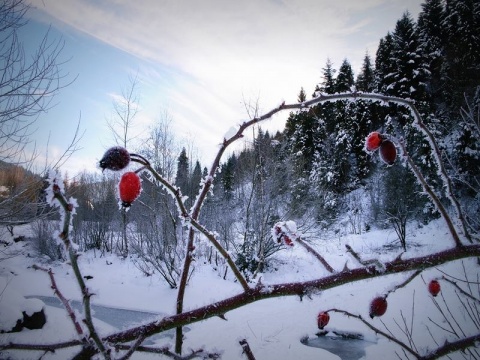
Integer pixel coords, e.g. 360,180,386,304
89,92,480,354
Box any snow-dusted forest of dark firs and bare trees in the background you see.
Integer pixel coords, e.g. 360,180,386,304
0,0,480,287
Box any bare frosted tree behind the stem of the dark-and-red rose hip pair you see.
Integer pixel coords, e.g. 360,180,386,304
131,111,184,288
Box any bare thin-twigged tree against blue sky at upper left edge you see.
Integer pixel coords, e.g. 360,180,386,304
0,0,71,162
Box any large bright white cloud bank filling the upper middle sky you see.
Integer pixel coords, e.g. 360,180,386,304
28,0,419,170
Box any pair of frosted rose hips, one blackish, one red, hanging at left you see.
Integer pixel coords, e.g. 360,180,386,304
99,146,142,208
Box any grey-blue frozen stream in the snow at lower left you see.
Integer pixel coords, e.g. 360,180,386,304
27,296,190,344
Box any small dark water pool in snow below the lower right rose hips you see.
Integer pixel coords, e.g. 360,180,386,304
302,336,374,360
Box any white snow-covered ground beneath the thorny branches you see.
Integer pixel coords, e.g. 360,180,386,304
0,219,479,360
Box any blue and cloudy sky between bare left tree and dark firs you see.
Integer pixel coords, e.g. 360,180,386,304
21,0,422,176
